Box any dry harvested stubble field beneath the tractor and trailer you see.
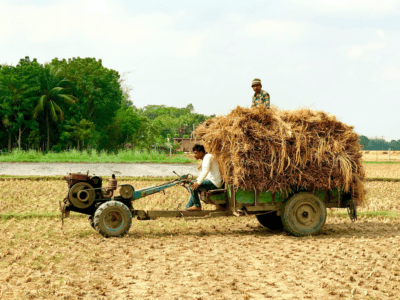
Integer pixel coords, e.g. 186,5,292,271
0,168,400,299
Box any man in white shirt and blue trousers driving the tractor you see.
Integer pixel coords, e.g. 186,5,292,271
185,144,222,211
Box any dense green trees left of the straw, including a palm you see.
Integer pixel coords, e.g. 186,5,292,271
0,56,214,152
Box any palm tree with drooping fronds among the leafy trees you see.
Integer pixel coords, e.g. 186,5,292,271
33,64,78,150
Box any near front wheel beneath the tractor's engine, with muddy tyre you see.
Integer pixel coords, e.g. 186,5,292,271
94,201,132,237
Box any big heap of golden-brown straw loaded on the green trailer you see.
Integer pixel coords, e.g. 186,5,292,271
196,106,365,205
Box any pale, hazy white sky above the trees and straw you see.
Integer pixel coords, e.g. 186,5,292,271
0,0,400,141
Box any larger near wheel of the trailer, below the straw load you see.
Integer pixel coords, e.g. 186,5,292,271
282,192,326,236
